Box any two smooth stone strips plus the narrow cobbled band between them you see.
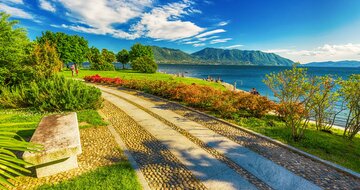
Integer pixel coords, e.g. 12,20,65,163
98,86,334,189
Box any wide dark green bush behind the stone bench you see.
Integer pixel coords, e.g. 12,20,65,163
0,76,102,111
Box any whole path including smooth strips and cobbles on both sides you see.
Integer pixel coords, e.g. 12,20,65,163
98,86,360,189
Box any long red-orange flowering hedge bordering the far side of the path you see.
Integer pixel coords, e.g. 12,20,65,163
84,75,275,118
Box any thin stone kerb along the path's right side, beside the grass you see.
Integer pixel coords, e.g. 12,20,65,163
129,87,360,179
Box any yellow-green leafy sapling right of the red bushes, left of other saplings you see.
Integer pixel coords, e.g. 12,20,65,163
264,64,316,141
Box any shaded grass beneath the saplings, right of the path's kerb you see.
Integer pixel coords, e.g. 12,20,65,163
212,113,360,172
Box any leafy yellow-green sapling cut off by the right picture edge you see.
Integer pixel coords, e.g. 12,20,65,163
340,74,360,140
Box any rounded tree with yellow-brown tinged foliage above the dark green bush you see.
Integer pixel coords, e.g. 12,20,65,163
30,42,63,78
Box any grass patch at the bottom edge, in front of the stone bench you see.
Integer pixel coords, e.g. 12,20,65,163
38,160,141,190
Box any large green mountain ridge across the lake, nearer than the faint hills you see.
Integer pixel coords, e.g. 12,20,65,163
152,46,294,66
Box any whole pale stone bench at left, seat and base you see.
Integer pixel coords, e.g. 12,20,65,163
23,112,81,177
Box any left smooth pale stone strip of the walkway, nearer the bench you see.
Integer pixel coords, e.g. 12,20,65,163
102,92,256,189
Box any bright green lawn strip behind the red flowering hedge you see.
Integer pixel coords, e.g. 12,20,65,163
60,70,225,89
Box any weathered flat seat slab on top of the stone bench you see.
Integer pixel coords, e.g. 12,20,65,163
23,112,82,165
